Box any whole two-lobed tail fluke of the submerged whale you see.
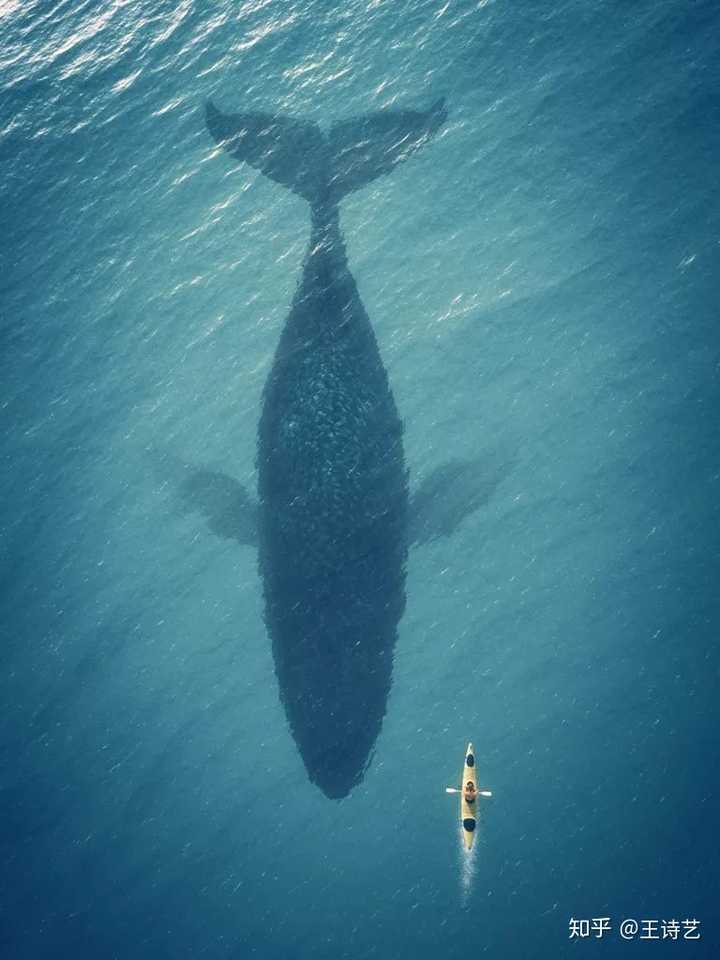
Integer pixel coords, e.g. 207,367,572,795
205,98,447,205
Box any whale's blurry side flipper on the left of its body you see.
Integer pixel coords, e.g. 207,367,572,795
180,467,257,547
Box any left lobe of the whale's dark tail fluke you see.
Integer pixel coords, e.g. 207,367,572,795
205,100,326,202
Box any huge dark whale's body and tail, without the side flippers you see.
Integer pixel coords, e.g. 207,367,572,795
206,100,447,798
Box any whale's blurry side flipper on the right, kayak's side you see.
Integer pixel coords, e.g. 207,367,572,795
410,456,511,545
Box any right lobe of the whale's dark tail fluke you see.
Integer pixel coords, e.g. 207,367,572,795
329,97,447,200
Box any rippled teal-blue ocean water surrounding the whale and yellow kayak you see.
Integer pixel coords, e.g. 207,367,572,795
0,0,720,960
